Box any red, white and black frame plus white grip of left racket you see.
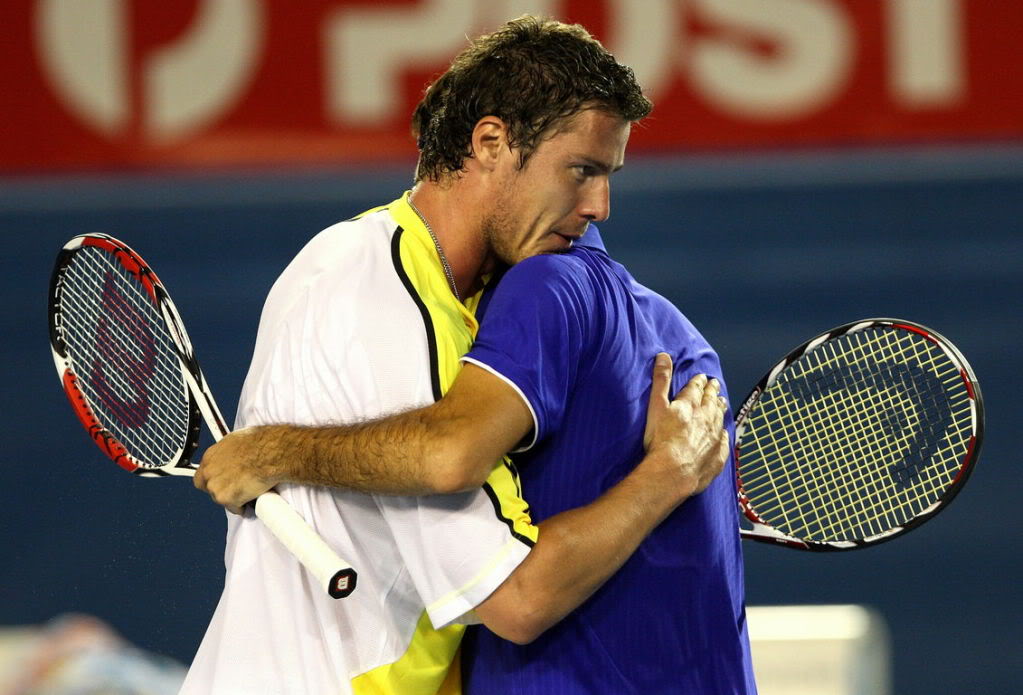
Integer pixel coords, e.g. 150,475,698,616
48,233,358,599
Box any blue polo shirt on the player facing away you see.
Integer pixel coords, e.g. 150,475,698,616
462,227,756,695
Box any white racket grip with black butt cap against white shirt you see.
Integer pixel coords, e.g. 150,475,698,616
256,490,358,599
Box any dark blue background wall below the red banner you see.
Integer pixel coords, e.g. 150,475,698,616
0,147,1023,695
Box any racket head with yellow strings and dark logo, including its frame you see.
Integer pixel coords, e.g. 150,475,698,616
735,318,984,551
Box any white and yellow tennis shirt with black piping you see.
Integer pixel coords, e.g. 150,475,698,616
181,193,537,695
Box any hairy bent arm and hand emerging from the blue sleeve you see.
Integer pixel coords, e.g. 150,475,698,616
195,364,533,513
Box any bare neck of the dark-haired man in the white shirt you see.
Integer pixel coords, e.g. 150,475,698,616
411,178,493,299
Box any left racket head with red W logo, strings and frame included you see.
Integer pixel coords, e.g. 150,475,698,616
49,234,201,476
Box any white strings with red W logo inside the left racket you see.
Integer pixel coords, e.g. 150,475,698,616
57,247,189,468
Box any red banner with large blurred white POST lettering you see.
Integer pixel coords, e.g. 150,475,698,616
0,0,1023,174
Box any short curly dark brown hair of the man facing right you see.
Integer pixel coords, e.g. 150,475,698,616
412,15,653,181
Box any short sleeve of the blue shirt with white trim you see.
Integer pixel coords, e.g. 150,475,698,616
462,255,601,450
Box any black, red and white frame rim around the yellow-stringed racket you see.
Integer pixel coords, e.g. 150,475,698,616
733,317,984,552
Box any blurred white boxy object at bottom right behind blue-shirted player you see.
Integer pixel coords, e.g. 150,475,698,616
747,605,891,695
